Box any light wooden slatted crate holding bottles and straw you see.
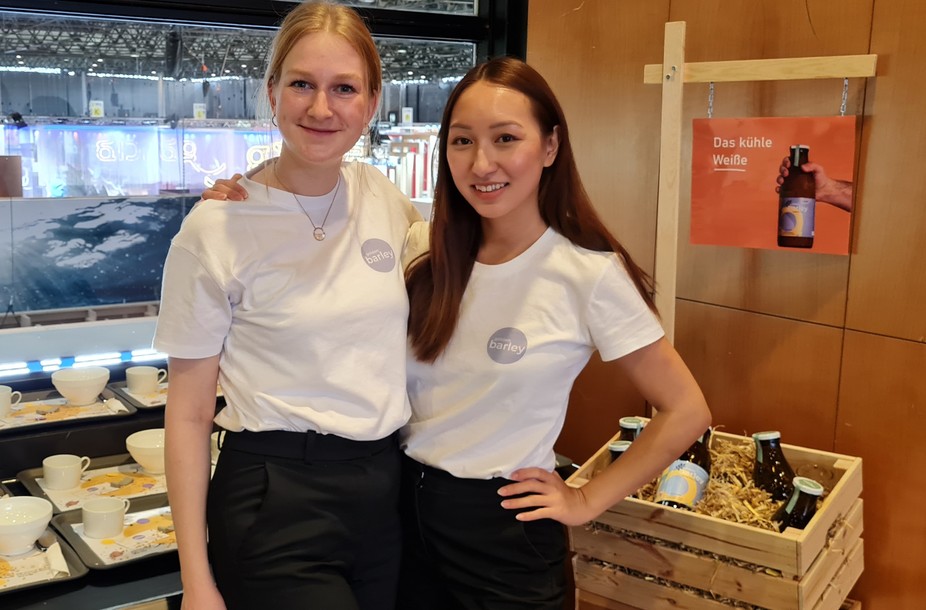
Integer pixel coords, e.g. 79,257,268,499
567,432,864,610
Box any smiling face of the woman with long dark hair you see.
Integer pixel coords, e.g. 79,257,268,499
447,81,558,220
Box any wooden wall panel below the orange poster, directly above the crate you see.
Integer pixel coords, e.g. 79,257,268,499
676,300,842,451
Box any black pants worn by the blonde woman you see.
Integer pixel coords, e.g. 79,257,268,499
207,432,401,610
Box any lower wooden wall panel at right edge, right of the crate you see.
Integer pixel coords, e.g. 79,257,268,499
836,331,926,610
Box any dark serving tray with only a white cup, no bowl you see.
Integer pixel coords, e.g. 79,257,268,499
51,495,177,570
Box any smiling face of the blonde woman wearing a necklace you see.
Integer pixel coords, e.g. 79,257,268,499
269,32,378,165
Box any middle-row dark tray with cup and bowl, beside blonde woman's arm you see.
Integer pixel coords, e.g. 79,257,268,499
16,453,167,514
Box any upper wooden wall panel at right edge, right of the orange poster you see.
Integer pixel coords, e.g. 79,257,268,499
846,0,926,341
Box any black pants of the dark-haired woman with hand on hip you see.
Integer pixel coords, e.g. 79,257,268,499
398,458,566,610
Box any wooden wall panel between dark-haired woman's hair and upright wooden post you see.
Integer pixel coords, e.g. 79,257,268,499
527,0,669,272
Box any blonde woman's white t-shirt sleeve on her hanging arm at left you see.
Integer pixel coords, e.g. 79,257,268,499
154,243,232,358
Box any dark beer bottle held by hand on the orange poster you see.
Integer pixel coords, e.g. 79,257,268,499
778,144,817,248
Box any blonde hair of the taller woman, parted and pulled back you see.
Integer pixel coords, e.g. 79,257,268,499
264,2,383,98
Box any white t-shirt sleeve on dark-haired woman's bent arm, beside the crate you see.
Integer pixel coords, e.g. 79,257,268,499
587,255,665,361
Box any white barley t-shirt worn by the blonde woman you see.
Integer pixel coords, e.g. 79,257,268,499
154,163,420,440
